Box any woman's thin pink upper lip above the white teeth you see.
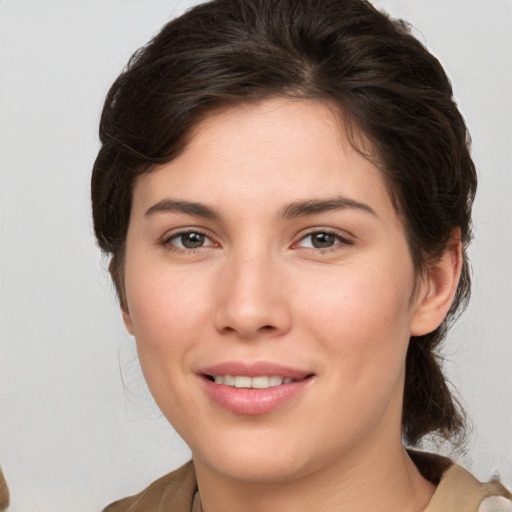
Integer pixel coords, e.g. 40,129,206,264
198,361,313,380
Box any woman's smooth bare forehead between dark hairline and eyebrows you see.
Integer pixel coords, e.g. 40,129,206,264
134,98,396,223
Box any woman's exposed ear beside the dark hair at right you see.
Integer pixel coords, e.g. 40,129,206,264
411,228,462,336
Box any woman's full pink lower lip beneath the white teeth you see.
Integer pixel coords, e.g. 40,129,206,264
202,377,312,415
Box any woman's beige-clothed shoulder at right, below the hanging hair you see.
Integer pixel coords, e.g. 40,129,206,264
410,452,512,512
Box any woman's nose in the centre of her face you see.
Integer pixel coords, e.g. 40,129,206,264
215,254,292,339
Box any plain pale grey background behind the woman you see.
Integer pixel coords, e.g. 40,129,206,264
0,0,512,512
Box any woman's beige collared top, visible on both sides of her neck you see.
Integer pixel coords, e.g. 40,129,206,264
103,452,512,512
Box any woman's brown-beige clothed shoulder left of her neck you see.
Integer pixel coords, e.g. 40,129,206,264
103,461,197,512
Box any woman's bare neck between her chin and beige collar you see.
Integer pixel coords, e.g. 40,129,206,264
196,440,435,512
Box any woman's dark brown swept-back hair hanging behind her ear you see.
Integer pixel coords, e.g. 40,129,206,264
92,0,476,445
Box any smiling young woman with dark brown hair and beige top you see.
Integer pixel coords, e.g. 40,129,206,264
92,0,510,512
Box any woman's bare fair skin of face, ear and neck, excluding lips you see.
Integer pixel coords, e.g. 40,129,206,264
123,99,460,512
